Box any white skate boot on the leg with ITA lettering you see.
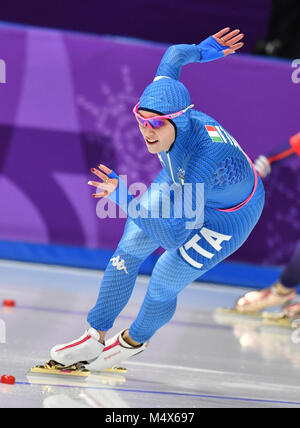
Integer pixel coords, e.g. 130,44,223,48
85,329,149,371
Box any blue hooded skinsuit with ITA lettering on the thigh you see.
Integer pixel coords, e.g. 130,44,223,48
88,38,264,343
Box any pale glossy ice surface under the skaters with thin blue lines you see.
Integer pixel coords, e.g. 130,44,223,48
0,261,300,409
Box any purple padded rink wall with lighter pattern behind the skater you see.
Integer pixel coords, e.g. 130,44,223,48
0,23,300,264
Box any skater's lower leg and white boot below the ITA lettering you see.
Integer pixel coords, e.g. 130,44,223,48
88,250,200,371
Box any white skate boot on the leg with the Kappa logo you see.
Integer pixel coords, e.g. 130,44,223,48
50,328,104,366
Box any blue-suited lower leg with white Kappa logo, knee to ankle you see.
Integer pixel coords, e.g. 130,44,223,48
88,220,158,332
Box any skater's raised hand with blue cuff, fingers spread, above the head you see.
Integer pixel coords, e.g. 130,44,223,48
197,27,244,62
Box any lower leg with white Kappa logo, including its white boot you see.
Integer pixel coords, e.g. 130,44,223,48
50,220,158,365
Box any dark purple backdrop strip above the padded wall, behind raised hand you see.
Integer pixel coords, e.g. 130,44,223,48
0,0,272,52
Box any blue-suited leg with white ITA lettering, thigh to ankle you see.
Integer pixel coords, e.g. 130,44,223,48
129,198,262,343
